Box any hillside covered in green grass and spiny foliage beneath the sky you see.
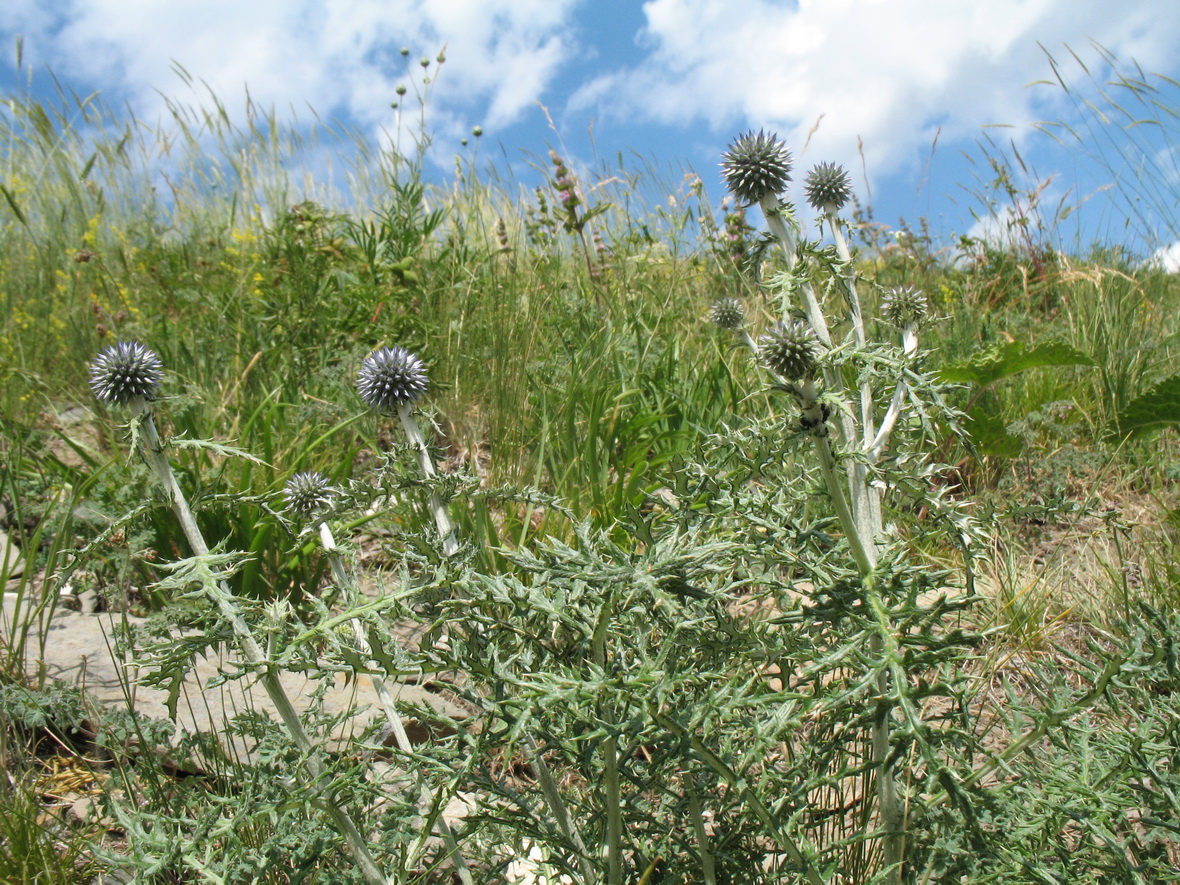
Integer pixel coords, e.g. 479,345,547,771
0,74,1180,884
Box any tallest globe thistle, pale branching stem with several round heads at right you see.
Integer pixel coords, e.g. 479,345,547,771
710,132,972,885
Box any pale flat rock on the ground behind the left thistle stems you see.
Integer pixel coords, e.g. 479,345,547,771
0,594,467,759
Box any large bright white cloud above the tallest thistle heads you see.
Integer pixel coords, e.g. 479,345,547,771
571,0,1180,185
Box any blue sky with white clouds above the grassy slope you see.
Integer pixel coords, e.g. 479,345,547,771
0,0,1180,255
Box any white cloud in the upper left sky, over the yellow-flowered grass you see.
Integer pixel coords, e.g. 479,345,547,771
0,0,578,133
